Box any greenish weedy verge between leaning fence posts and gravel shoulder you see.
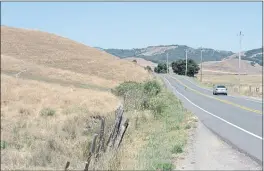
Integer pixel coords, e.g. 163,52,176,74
110,77,196,170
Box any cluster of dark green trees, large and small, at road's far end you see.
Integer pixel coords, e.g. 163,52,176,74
154,59,200,77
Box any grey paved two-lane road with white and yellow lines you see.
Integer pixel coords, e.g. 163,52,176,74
161,74,263,162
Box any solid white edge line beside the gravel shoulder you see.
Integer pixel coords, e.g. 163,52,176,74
163,77,263,140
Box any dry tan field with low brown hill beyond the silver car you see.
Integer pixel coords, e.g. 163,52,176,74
197,56,263,97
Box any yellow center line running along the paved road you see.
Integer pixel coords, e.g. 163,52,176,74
169,75,262,114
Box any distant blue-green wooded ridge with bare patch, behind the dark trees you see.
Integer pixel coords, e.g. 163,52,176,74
105,45,234,63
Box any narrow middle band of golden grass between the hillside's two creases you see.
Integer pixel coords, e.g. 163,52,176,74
1,55,118,88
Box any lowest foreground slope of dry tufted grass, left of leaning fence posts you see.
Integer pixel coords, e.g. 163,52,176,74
1,74,119,169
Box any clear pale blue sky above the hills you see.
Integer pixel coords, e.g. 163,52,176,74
1,2,262,52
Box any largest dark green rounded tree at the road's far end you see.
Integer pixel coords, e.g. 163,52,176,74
171,59,200,77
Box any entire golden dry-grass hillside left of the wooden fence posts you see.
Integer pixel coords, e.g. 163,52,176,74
1,26,151,169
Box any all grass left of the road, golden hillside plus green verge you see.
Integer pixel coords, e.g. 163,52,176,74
1,26,192,170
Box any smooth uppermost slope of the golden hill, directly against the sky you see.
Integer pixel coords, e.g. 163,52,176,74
1,26,150,82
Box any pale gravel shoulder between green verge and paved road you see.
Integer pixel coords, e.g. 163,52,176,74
175,121,262,170
